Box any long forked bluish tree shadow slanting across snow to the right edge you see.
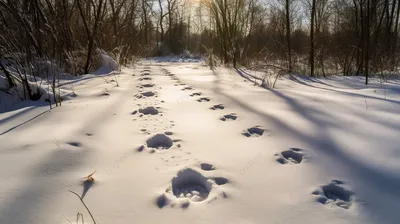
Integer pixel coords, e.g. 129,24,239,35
215,69,400,222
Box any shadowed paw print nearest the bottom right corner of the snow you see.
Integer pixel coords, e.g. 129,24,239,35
312,180,354,209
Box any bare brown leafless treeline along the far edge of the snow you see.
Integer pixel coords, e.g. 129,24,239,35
0,0,400,84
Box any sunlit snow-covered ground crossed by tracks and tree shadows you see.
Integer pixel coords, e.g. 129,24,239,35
0,61,400,224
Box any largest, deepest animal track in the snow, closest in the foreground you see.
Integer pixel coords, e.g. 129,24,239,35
156,168,229,209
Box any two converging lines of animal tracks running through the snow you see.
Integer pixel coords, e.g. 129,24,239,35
134,68,355,212
